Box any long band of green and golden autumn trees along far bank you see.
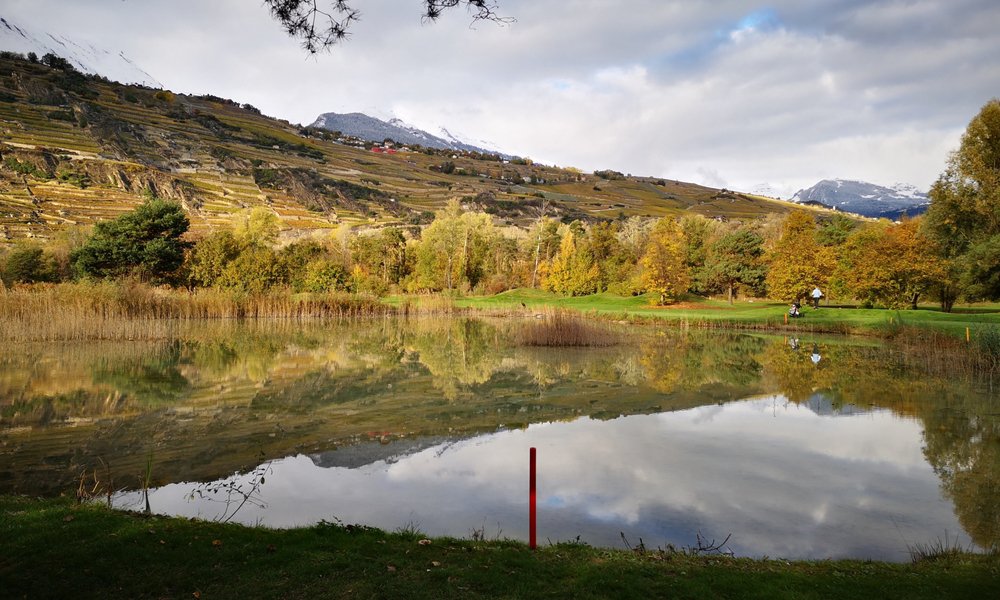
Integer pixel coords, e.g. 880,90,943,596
0,95,1000,321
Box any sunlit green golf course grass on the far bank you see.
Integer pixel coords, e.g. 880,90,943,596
455,289,1000,337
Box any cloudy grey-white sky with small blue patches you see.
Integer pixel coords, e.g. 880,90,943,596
0,0,1000,195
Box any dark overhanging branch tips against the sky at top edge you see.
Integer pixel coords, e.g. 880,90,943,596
264,0,514,54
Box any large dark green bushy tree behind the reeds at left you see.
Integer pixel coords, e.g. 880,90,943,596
70,199,190,282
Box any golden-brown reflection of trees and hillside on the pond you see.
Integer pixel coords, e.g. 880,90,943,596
0,318,1000,548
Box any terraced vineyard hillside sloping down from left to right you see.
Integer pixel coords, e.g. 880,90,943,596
0,53,820,242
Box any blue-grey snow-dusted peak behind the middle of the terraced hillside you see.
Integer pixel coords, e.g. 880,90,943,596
312,113,506,156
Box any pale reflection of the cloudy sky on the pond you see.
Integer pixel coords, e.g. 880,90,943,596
115,396,967,560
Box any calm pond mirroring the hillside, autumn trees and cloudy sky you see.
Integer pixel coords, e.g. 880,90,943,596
0,318,1000,561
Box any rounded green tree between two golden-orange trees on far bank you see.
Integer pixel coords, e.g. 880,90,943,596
704,228,767,304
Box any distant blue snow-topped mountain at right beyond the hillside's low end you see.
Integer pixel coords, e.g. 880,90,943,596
792,179,930,219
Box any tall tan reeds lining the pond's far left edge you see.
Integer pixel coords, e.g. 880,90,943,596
0,281,396,342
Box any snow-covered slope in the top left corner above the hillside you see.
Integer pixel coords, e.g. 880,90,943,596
0,17,163,88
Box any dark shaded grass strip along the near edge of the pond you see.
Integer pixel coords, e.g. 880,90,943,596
0,497,1000,599
